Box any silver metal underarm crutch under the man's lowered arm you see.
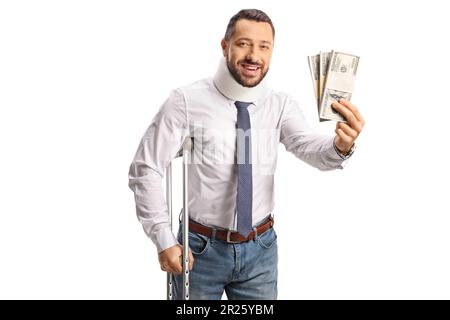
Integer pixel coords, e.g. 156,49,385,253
166,137,193,300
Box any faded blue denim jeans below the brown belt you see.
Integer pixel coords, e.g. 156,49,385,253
173,222,278,300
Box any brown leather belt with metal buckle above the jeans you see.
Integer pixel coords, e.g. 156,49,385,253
189,216,273,243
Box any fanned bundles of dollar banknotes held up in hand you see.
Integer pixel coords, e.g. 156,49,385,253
308,51,359,122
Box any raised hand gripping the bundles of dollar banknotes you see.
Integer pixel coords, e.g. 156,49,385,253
332,99,365,154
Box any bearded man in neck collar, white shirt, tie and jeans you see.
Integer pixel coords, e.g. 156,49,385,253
129,9,364,299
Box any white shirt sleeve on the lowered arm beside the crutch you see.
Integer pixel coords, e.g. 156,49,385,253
128,89,188,253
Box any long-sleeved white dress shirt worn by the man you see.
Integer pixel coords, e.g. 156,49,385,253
129,57,354,252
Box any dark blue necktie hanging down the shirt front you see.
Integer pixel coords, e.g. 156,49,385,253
234,101,253,237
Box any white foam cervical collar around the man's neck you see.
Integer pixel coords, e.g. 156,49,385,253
213,57,269,102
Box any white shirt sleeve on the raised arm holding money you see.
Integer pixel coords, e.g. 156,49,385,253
280,97,350,171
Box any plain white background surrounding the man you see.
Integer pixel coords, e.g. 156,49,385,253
0,1,450,299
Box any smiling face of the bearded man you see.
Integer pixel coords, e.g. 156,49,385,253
221,19,273,87
